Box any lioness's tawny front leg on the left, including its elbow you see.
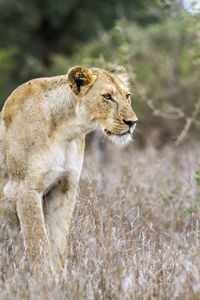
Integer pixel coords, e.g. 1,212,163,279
3,180,53,280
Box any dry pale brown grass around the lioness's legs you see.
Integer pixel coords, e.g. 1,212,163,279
0,137,200,300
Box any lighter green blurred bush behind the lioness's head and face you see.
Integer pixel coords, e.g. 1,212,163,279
50,16,200,147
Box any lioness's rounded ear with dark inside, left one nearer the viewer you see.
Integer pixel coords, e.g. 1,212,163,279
67,66,96,97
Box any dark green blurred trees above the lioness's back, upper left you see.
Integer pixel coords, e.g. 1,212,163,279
0,0,158,103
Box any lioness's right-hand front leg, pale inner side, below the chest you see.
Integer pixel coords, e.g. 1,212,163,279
44,172,78,271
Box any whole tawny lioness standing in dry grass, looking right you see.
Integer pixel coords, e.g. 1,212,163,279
0,66,137,272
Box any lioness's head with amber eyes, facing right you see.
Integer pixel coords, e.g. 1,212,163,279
68,66,138,145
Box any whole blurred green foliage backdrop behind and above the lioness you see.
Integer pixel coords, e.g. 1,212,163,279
0,0,200,146
